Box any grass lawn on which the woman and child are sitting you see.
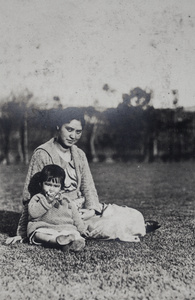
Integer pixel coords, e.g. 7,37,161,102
0,162,195,300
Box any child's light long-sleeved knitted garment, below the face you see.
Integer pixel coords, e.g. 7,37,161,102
27,193,86,243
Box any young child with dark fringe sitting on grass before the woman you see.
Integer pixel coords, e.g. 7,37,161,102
27,165,87,251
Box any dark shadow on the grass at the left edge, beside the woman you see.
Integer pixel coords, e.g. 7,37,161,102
0,210,21,236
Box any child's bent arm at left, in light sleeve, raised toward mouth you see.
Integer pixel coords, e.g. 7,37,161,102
28,194,53,219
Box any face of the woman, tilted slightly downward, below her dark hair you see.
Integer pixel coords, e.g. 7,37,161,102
58,120,83,148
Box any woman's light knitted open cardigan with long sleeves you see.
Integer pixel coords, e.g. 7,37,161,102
17,138,101,237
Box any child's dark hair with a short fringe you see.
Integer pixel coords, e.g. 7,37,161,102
28,164,65,197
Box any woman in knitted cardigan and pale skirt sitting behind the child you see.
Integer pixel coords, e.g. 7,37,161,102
7,108,158,244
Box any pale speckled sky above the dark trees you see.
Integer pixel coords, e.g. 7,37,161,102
0,0,195,108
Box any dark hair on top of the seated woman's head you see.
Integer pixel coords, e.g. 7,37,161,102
56,107,85,127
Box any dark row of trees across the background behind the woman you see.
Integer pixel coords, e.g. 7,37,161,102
0,88,195,164
